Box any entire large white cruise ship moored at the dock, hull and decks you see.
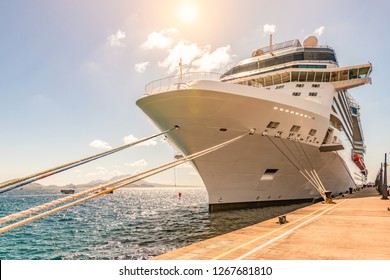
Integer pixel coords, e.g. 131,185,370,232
137,35,372,211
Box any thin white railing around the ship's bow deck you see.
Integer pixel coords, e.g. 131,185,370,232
145,72,221,95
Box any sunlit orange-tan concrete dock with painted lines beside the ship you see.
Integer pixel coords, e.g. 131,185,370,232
154,188,390,260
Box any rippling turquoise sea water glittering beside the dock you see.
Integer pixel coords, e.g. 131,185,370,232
0,188,303,260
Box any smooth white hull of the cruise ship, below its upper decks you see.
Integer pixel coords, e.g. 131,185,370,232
137,81,364,210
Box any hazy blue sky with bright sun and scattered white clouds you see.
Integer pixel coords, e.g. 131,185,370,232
0,0,390,186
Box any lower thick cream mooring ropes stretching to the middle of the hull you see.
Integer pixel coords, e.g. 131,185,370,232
0,130,254,233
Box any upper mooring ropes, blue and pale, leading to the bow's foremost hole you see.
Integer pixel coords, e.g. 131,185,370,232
0,126,179,194
